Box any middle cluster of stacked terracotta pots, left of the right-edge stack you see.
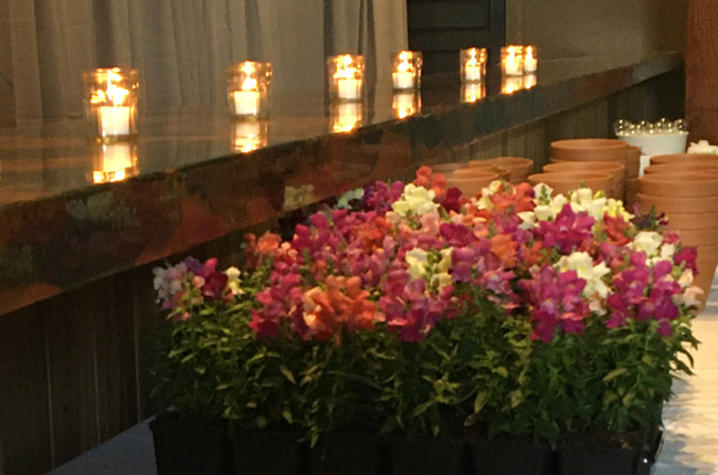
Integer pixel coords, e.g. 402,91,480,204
529,138,640,199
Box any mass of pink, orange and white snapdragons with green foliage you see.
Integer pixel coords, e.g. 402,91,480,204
155,167,700,458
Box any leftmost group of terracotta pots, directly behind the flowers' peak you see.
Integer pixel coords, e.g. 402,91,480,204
424,157,533,196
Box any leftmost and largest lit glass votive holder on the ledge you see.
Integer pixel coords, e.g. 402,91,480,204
82,68,140,142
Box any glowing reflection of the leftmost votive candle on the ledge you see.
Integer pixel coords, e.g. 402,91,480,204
91,142,140,184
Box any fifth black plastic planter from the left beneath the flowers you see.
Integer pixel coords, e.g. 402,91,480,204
467,438,556,475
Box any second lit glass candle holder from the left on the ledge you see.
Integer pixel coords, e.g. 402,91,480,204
227,61,272,118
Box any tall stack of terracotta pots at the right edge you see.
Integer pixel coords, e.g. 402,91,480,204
637,154,718,304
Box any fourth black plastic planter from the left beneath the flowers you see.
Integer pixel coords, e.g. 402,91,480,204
391,436,464,475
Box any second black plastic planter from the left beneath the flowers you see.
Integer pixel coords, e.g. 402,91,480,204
232,428,306,475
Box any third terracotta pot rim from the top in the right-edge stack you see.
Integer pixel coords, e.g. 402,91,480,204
638,172,718,198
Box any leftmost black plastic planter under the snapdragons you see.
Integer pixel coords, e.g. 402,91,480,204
150,411,229,475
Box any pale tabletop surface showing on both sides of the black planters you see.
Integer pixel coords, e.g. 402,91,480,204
50,273,718,475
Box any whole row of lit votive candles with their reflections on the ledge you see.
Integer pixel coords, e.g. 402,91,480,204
84,45,538,183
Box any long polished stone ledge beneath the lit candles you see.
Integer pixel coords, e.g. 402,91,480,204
0,54,682,314
